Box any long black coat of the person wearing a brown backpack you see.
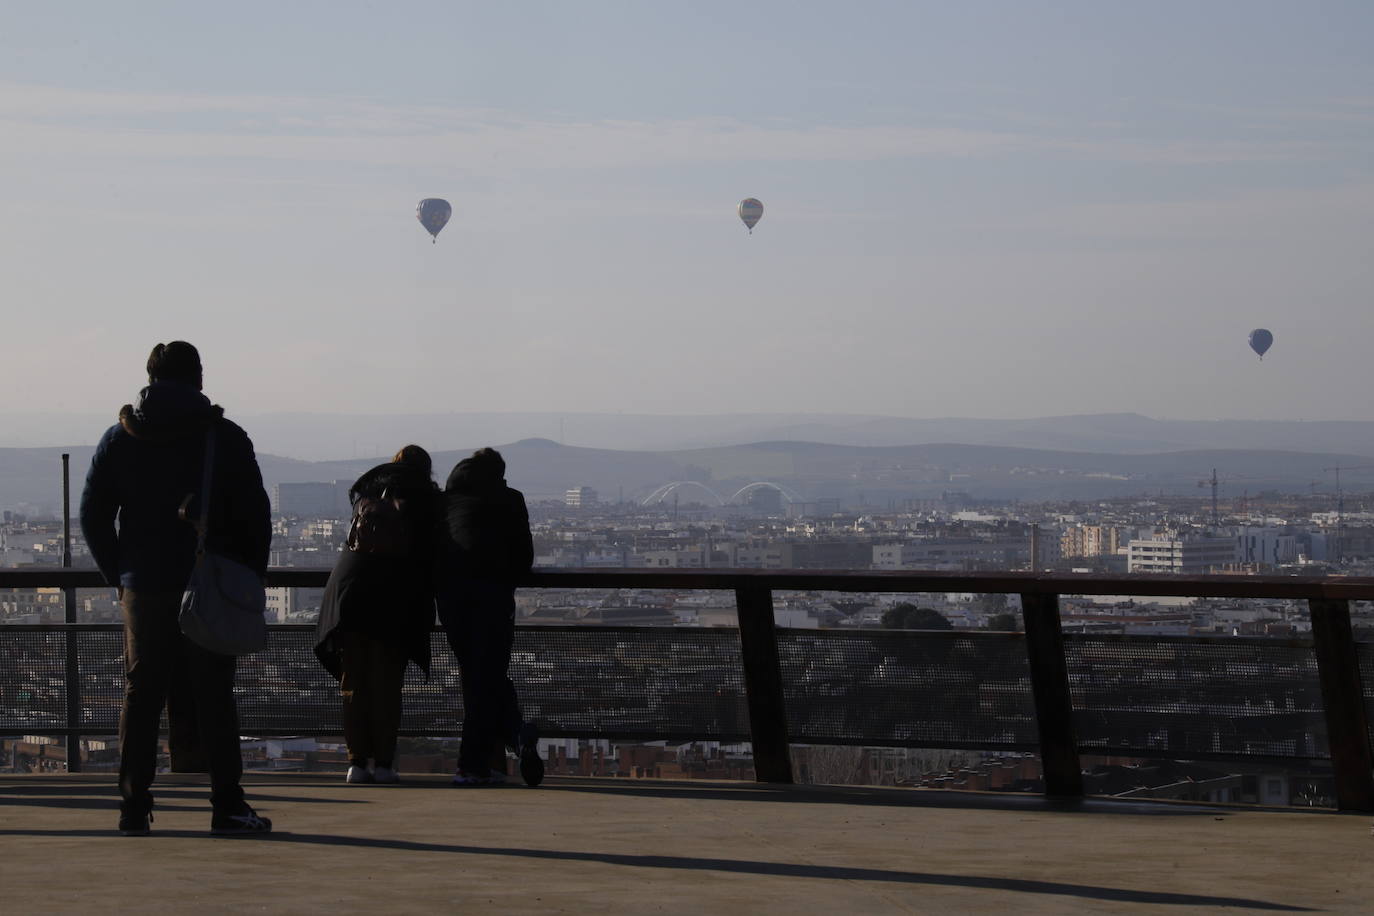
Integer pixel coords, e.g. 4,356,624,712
315,463,438,677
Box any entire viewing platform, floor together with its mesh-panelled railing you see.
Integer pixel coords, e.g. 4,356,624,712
0,569,1374,913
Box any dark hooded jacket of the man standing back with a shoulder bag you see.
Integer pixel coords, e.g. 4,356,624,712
81,380,272,592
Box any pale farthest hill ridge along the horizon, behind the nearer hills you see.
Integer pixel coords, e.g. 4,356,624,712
13,409,1374,461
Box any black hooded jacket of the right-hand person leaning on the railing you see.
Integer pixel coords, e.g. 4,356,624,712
438,456,534,585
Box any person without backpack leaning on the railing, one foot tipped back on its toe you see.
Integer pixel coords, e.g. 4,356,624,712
437,449,544,786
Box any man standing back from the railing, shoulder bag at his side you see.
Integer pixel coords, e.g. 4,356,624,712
81,341,272,836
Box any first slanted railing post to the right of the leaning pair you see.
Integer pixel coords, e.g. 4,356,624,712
735,588,791,784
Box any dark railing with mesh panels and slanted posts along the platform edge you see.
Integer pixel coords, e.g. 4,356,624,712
0,569,1374,812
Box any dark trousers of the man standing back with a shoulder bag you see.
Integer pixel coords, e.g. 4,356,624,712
120,589,243,812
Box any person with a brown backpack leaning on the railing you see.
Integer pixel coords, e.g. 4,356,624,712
315,445,438,783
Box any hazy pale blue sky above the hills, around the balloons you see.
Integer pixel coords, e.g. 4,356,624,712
0,0,1374,419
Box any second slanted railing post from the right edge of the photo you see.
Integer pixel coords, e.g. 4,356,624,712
1021,595,1083,798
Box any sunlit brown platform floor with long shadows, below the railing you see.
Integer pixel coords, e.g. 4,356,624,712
0,775,1374,913
